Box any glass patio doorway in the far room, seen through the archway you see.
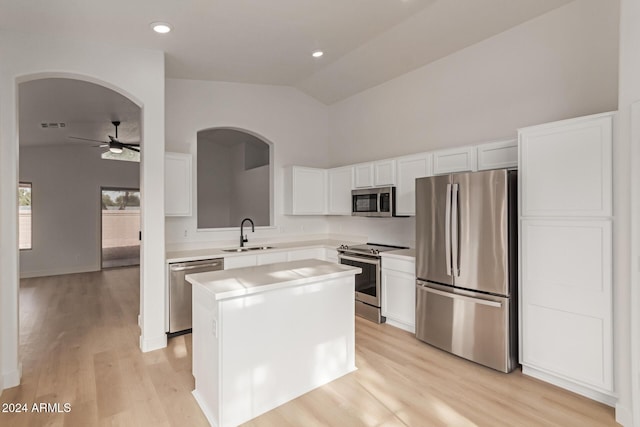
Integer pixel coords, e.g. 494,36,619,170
100,187,140,269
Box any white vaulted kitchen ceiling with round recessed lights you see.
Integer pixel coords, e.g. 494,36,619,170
0,0,571,104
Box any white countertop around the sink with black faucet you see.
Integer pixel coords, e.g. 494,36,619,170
166,239,358,262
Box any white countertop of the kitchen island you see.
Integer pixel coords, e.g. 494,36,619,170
185,259,362,300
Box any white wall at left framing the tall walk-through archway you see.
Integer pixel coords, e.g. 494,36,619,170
0,31,166,387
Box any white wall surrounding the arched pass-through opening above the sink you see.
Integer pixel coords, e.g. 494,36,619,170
166,79,329,249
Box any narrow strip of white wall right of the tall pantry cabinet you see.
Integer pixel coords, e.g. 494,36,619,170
613,0,640,426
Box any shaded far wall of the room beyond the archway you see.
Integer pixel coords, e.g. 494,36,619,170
19,145,140,277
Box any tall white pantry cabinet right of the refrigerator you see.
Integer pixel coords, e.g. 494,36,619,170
518,113,615,405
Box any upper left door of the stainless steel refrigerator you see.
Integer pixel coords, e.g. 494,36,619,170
416,175,453,285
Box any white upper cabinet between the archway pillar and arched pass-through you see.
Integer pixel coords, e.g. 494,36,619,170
164,153,192,216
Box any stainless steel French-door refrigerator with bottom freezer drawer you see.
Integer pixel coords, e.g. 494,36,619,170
416,170,517,372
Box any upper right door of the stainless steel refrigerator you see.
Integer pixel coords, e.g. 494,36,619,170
451,169,509,296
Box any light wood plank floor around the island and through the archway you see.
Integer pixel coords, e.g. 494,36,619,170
0,268,616,427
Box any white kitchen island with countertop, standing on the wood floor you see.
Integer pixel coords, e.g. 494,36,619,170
186,259,360,427
